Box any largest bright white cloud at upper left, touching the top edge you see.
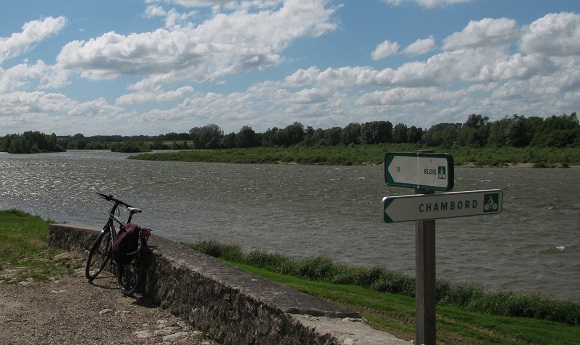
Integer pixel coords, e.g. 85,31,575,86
57,0,336,87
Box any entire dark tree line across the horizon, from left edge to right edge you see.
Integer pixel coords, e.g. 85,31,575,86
0,112,580,153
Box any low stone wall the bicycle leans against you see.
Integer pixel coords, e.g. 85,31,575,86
49,224,408,345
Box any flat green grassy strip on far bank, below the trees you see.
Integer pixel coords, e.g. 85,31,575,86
130,144,580,167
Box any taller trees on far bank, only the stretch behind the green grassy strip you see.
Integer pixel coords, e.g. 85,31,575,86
177,113,580,149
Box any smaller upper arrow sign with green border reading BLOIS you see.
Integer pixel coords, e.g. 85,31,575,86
385,152,454,191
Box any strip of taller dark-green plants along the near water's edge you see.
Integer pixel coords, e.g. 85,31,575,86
185,241,580,325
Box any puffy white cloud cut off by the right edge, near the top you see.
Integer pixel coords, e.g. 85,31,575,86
520,12,580,56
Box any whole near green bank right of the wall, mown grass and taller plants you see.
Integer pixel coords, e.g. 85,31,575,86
187,241,580,344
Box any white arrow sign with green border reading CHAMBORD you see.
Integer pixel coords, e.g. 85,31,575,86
383,189,503,223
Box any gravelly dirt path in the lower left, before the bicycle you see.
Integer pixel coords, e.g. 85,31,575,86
0,264,216,345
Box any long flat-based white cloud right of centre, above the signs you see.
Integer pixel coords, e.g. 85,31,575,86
286,48,555,87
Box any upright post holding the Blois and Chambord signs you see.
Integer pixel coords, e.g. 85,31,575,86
415,189,437,345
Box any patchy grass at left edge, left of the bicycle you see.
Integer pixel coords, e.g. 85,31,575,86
0,210,80,283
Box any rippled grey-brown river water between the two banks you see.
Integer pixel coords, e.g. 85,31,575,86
0,151,580,301
